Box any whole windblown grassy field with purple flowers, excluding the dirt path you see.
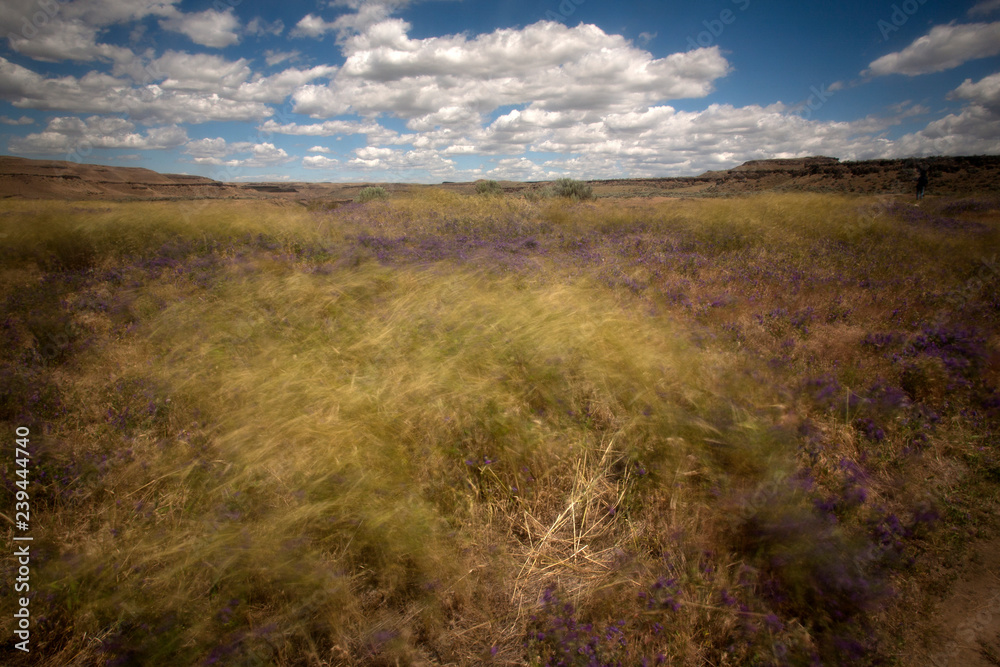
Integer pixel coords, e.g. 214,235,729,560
0,190,1000,667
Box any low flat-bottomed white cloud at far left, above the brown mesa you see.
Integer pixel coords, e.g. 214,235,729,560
8,116,187,154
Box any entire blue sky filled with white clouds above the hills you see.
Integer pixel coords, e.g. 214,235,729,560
0,0,1000,183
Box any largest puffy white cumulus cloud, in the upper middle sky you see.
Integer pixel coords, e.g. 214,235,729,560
293,19,730,122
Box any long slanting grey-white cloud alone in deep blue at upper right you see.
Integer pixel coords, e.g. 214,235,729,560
861,21,1000,76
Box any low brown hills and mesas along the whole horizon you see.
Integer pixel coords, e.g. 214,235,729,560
0,155,1000,202
